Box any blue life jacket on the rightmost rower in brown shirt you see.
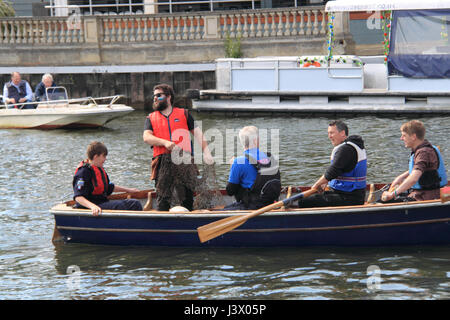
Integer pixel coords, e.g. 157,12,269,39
409,145,447,190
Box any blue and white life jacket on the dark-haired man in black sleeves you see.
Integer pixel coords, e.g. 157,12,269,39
328,141,367,192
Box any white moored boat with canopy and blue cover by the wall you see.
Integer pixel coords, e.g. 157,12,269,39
193,0,450,114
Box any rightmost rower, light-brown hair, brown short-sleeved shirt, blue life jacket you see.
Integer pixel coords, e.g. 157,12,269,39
381,120,447,202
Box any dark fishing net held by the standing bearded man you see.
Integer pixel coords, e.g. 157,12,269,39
156,154,224,210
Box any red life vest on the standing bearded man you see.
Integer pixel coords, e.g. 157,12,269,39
148,108,192,157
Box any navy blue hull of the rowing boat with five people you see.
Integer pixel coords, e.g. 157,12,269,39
51,201,450,247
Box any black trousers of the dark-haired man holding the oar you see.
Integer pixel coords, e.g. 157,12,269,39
298,190,365,208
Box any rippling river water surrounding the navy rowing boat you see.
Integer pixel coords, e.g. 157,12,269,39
0,111,450,300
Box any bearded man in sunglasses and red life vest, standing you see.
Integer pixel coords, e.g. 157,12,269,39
143,84,214,211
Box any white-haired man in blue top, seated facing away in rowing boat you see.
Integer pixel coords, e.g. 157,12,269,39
223,126,281,210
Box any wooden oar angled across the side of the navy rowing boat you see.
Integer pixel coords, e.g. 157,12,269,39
197,189,317,242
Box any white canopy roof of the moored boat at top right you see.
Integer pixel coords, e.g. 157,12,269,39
325,0,450,12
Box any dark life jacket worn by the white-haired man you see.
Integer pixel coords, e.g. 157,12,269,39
242,153,281,210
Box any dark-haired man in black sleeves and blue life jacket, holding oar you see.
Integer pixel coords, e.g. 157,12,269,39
298,120,367,208
